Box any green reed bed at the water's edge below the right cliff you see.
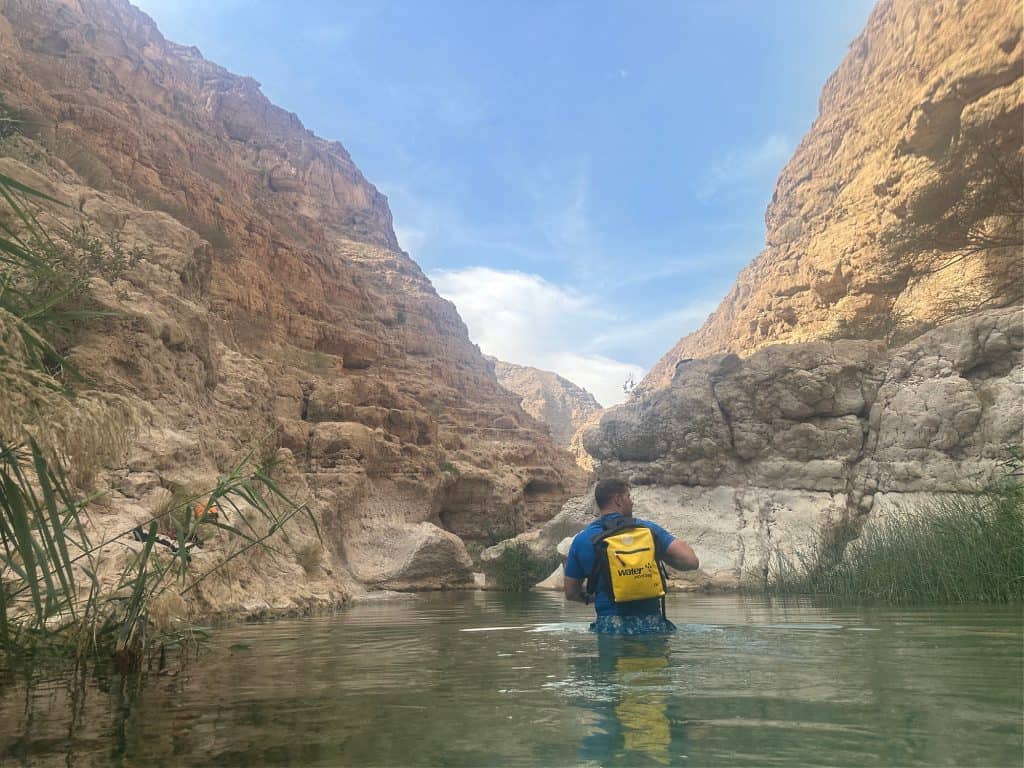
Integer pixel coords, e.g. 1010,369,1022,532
768,450,1024,604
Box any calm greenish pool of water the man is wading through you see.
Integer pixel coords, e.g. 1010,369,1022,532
0,592,1024,766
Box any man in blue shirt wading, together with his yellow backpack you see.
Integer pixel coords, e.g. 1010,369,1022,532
565,480,700,635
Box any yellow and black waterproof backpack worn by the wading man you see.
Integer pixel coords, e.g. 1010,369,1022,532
588,525,665,603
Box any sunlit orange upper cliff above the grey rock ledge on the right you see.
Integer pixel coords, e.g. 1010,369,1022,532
640,0,1024,389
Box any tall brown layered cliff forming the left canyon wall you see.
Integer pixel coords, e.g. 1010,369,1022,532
0,0,583,610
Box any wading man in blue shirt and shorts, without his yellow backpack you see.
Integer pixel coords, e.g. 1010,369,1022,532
565,480,700,635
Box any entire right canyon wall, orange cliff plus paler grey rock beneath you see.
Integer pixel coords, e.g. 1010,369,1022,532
570,0,1024,587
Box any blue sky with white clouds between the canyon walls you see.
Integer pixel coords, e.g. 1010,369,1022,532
135,0,873,406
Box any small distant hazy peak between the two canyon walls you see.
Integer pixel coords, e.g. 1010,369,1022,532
488,357,601,447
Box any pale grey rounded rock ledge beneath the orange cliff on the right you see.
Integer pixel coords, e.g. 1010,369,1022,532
581,306,1024,586
